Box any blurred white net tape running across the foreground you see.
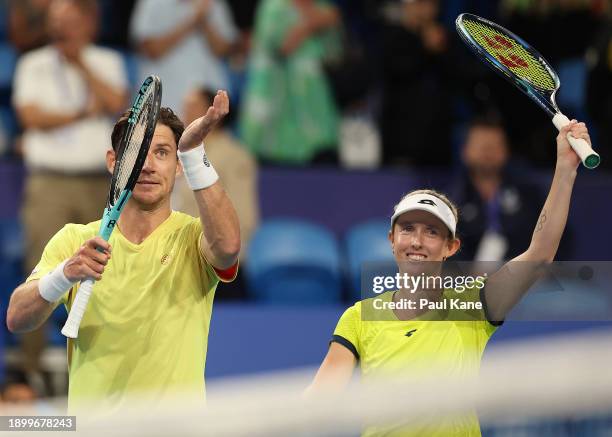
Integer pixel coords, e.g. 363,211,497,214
3,331,612,437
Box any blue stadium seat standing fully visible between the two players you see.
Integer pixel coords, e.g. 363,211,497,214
245,219,342,304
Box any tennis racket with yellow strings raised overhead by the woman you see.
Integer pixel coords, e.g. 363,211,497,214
455,14,601,169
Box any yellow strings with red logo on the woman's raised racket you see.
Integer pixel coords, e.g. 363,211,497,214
464,20,557,91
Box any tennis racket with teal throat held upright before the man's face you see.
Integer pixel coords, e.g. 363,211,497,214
62,76,162,338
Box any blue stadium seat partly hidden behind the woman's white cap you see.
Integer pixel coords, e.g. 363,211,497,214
345,219,395,300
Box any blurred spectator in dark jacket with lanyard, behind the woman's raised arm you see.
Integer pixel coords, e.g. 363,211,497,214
449,118,552,261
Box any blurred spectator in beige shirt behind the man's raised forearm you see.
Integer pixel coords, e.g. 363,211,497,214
173,88,259,257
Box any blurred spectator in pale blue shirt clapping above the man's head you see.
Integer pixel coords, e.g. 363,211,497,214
131,0,238,108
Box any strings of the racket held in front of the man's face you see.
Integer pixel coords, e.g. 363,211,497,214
112,88,154,205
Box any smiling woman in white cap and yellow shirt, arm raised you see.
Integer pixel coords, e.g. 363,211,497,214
309,120,590,437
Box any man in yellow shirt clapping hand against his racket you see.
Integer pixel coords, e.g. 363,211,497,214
7,92,240,410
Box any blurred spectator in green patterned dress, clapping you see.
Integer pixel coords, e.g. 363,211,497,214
240,0,340,164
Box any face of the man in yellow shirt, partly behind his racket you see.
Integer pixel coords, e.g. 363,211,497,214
108,124,181,210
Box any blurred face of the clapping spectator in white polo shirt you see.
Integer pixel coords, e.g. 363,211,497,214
47,0,94,58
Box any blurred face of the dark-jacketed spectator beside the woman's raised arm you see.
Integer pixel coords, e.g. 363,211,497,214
463,126,508,173
